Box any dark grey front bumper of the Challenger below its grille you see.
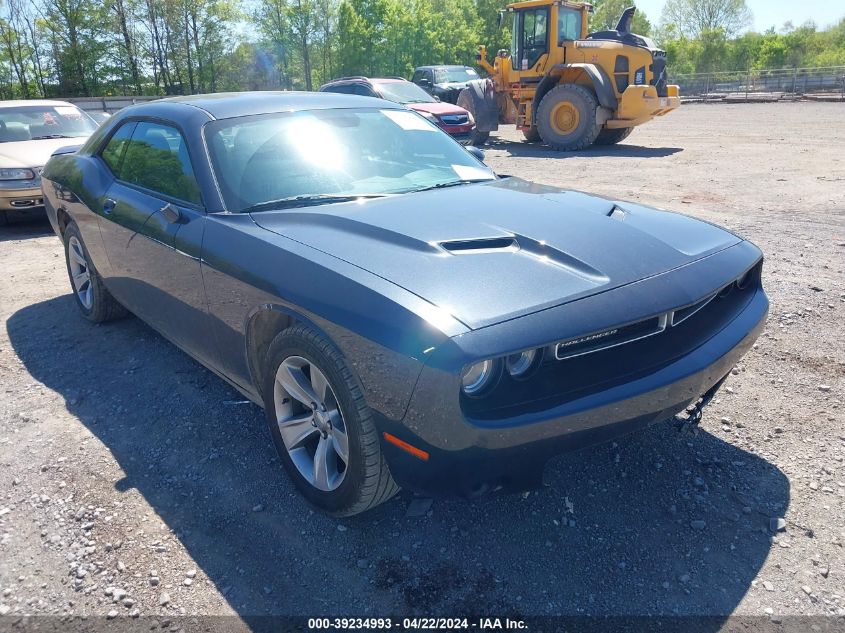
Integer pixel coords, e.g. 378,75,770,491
379,288,769,496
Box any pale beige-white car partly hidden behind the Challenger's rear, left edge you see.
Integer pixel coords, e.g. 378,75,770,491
0,100,97,225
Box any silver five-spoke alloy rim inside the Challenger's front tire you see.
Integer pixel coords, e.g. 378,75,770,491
273,356,349,492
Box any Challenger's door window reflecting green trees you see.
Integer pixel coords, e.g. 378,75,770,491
120,121,200,204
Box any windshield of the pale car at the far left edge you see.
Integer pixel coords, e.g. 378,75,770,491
0,104,97,143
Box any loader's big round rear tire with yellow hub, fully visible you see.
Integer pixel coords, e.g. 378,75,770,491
537,84,600,152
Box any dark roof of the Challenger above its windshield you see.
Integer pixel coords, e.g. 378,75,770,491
138,91,402,119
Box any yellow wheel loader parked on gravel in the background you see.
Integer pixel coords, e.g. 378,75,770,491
458,0,681,151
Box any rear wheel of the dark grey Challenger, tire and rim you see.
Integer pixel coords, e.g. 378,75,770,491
62,222,127,323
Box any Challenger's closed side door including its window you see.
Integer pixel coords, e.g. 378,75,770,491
94,120,218,366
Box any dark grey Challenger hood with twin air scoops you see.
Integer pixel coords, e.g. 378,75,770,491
252,178,741,329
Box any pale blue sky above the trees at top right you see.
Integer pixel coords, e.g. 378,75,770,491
635,0,845,32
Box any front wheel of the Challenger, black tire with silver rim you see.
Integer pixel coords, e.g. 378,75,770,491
262,325,399,517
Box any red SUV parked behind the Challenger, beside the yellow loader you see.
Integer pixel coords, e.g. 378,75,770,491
320,77,475,143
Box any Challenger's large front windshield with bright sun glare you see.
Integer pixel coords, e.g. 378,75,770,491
205,108,495,211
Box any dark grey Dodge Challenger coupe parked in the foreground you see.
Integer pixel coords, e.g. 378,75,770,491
38,93,768,515
